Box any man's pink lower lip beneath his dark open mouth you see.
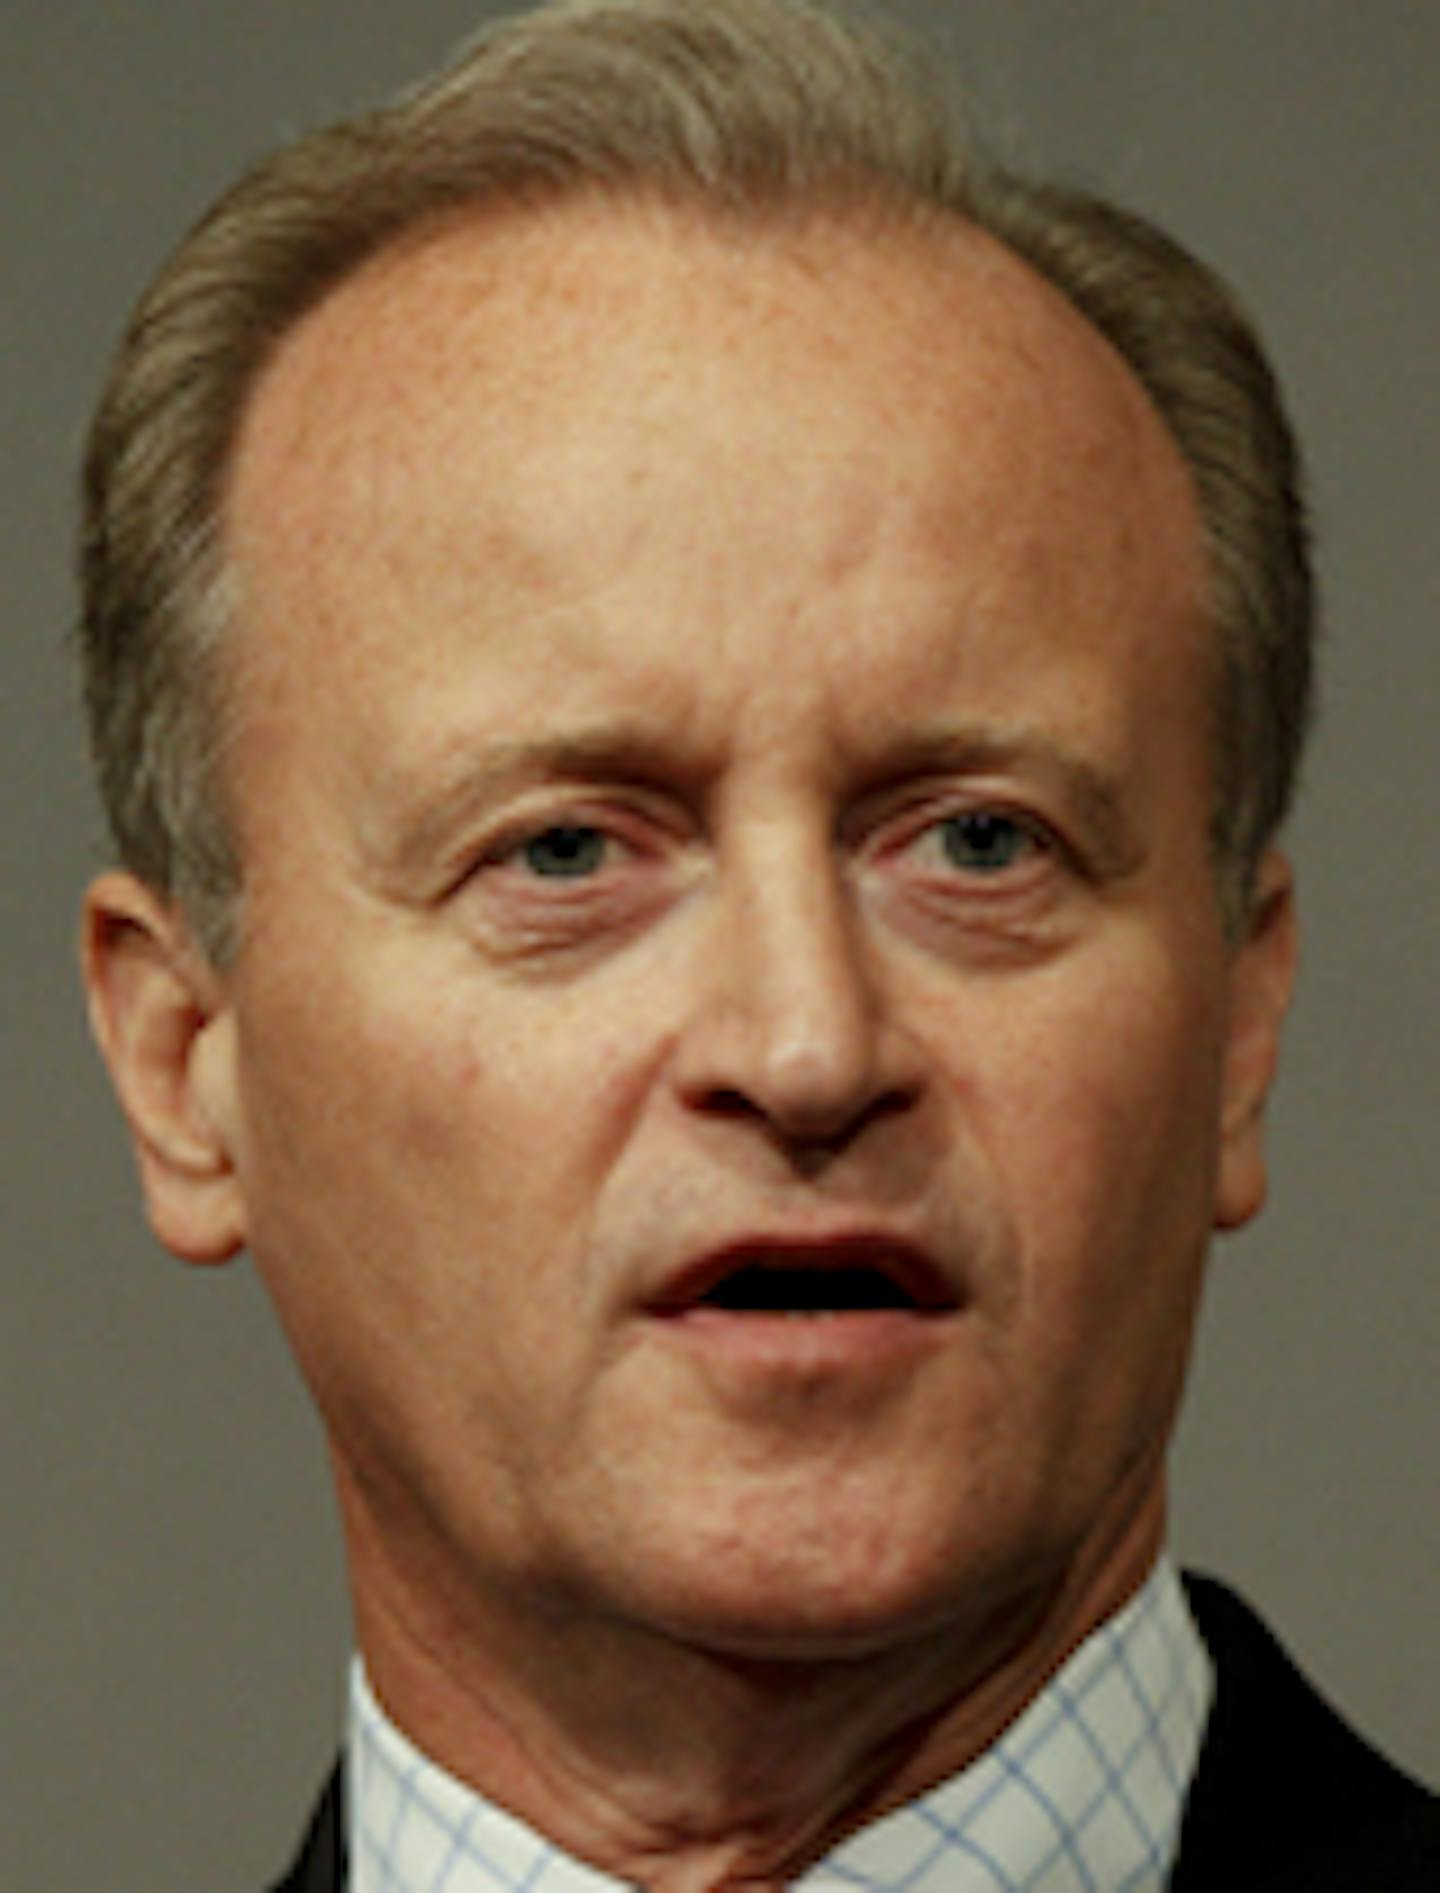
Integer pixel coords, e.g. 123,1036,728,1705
655,1306,956,1380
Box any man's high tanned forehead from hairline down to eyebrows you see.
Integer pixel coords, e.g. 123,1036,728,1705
227,192,1203,791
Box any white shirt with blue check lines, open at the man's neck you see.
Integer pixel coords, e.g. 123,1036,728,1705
348,1562,1215,1893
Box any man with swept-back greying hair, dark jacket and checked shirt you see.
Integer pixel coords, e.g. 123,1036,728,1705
85,0,1440,1893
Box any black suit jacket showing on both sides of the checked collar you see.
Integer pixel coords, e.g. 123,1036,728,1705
272,1579,1440,1893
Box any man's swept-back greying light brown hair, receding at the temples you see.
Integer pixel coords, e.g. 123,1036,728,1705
81,0,1313,958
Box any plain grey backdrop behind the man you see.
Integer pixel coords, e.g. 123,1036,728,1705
11,0,1440,1893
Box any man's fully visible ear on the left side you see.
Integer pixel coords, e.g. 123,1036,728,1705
81,873,244,1263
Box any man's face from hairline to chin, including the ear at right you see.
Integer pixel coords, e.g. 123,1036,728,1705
188,206,1294,1651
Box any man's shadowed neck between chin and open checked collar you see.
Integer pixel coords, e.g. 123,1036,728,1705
344,1494,1162,1893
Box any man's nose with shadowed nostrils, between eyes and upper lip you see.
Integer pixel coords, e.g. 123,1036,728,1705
676,839,922,1155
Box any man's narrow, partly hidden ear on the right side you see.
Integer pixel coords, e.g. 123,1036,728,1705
1215,850,1298,1229
